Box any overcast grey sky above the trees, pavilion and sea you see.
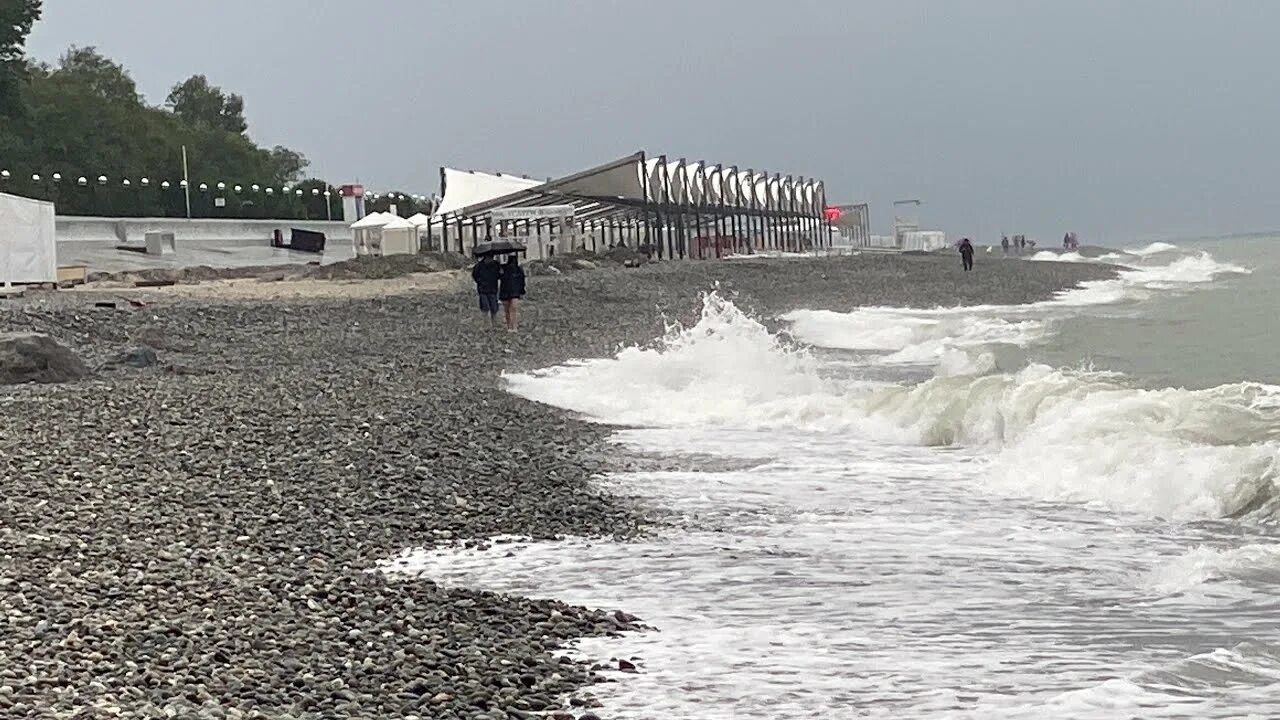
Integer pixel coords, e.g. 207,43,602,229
29,0,1280,243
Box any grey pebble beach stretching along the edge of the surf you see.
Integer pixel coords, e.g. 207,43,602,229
0,254,1115,719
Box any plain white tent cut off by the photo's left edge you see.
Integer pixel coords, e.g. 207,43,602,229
0,192,58,284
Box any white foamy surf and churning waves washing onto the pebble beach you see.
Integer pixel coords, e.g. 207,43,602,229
385,239,1280,720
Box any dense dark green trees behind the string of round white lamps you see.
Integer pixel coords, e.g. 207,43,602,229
0,0,432,219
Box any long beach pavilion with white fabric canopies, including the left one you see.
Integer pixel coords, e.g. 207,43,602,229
426,151,832,259
